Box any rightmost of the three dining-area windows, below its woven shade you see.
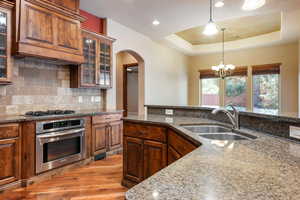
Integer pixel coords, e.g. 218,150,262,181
253,74,279,114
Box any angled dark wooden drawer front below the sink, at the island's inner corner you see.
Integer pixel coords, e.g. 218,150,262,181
168,130,197,156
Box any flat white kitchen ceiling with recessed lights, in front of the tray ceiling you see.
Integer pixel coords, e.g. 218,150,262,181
81,0,300,40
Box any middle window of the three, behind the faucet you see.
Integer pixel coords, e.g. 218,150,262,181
225,76,247,110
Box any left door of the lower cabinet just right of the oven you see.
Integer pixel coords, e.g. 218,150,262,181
92,124,109,155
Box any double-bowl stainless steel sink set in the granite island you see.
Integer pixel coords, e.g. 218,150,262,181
181,125,257,140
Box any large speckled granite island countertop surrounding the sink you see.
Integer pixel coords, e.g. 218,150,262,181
124,115,300,200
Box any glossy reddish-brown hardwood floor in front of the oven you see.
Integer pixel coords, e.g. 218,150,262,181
0,155,127,200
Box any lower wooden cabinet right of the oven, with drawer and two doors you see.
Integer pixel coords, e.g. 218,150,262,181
92,113,123,156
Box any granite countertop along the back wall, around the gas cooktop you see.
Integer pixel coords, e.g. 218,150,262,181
0,109,123,124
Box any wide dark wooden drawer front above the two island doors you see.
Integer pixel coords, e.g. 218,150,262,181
124,122,167,142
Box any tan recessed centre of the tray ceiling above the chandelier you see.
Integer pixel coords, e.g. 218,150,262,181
176,13,281,45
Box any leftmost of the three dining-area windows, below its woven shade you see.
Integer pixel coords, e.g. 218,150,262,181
201,78,220,106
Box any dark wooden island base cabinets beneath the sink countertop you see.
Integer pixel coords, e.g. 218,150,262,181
122,122,197,188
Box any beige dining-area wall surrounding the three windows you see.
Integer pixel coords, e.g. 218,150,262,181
188,43,300,113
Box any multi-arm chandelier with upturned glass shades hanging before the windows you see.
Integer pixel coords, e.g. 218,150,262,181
212,28,235,79
